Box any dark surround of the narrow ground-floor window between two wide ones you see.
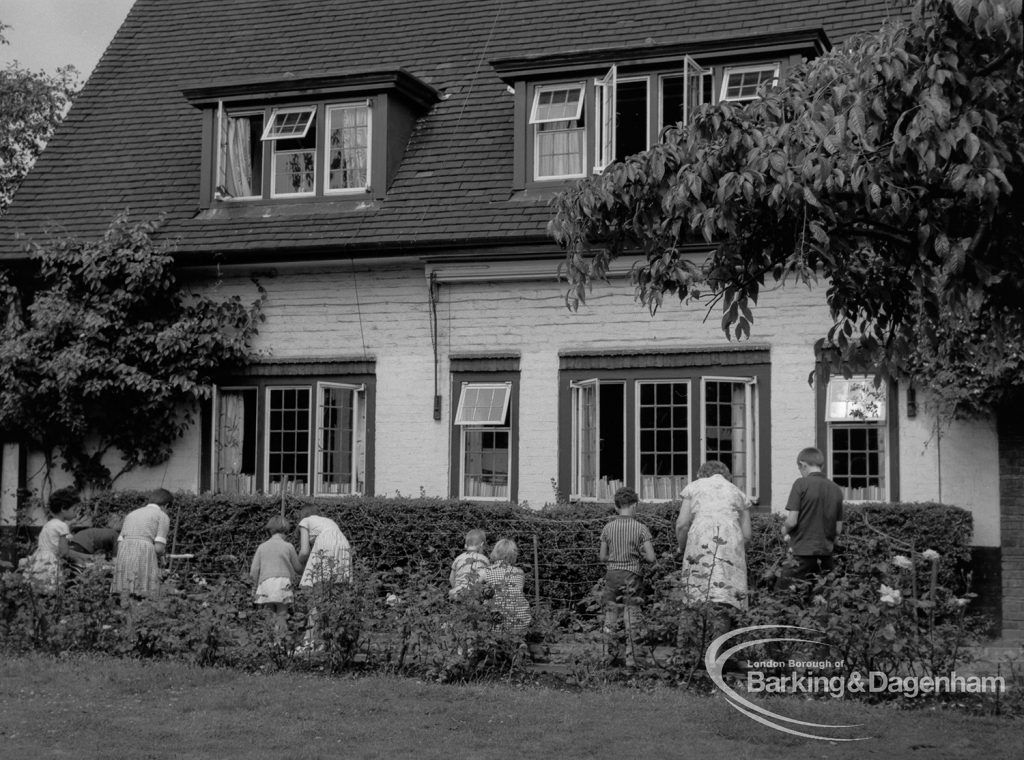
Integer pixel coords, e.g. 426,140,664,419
449,354,519,503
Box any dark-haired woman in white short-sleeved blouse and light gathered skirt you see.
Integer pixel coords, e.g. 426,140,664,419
111,489,174,598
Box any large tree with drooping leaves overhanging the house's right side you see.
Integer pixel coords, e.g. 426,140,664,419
550,0,1024,415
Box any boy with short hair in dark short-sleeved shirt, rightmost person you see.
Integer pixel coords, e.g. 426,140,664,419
775,448,843,590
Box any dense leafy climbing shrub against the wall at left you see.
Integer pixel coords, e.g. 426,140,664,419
0,215,263,488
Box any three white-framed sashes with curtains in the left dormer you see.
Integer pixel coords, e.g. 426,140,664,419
214,100,372,201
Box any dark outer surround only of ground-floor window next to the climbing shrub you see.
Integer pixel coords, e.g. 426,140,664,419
200,358,377,498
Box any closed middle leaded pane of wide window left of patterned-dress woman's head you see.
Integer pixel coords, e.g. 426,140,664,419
638,382,689,500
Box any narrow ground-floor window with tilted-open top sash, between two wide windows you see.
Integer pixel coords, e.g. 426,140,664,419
455,382,512,501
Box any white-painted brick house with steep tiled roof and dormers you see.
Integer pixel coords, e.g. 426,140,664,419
0,0,1011,635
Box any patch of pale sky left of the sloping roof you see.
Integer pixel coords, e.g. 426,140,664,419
0,0,134,81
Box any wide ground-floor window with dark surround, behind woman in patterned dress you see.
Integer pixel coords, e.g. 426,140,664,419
559,349,768,502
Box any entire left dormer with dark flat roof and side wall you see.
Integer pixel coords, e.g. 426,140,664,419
184,69,439,206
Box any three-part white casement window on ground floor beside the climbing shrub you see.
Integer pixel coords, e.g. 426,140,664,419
209,370,371,496
